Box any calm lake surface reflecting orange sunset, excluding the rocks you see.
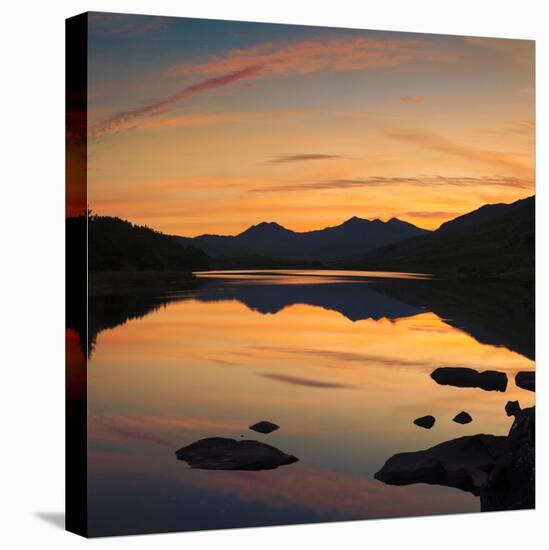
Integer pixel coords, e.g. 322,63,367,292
83,270,534,535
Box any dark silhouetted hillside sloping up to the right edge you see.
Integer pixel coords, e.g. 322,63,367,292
351,196,535,277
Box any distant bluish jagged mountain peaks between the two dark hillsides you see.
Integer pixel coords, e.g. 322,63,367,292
174,217,428,261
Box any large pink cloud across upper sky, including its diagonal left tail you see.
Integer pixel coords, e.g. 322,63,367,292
94,34,456,139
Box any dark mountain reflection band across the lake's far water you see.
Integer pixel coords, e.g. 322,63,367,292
84,271,535,360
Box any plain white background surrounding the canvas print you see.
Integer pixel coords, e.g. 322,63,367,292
0,0,549,550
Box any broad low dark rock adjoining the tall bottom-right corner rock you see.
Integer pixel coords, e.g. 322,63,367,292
374,434,507,496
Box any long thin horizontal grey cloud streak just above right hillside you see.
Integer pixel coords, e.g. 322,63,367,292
249,176,532,193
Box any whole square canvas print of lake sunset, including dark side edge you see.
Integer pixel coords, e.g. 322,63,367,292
66,13,535,537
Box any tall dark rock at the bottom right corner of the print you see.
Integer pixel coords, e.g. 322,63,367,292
480,407,536,512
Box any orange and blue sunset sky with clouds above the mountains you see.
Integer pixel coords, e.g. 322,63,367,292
88,13,535,236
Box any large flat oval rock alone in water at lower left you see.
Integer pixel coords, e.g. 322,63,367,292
175,437,299,470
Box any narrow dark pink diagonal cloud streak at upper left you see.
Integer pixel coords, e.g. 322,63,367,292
90,66,262,138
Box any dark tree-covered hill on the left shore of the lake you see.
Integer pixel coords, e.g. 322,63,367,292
85,216,209,272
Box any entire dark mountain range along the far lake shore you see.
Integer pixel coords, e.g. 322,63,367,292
75,196,535,281
